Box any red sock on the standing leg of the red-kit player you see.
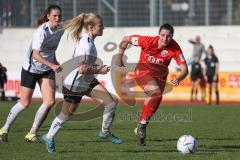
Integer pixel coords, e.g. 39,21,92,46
139,93,162,124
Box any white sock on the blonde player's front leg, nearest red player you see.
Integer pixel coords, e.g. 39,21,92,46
102,102,117,133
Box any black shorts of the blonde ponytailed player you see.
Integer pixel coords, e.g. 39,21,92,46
62,78,99,103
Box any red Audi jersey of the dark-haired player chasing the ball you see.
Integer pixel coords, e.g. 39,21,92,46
130,35,186,79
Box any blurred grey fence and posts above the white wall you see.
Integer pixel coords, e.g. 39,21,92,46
0,0,240,27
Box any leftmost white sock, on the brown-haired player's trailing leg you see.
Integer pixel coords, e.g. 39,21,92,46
2,102,25,132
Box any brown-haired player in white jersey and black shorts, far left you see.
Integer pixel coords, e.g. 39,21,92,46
0,5,64,142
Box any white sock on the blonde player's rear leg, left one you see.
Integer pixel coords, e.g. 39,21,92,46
47,113,70,139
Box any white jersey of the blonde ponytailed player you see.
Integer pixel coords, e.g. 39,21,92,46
64,33,97,92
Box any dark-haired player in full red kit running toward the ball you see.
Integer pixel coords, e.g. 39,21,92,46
116,24,188,145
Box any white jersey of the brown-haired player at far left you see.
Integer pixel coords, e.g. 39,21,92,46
23,22,64,74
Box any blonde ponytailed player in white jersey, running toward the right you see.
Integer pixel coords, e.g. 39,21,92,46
42,13,122,153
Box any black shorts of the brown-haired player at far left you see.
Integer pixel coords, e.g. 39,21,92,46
20,68,55,89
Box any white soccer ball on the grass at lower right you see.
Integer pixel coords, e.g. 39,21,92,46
177,135,197,154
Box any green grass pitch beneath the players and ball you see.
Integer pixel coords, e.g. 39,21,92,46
0,102,240,160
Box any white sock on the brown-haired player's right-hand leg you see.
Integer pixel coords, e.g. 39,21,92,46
29,103,49,134
